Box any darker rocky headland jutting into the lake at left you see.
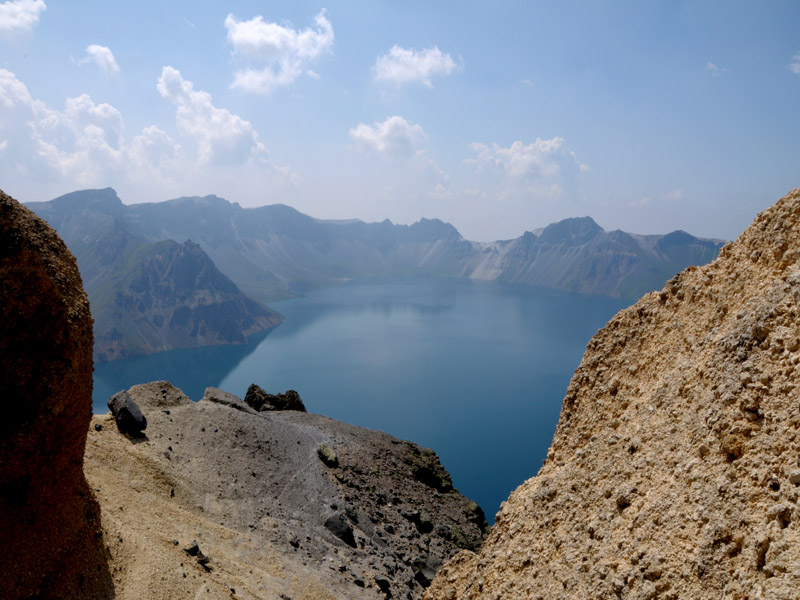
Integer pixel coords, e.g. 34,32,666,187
92,236,282,362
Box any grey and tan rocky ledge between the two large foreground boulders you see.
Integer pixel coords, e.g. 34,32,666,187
86,381,487,600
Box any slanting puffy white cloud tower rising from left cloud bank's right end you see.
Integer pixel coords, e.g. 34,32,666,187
157,66,267,165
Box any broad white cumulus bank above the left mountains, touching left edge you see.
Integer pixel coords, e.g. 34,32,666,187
0,67,296,199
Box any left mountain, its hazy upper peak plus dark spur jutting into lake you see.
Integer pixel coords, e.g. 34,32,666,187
28,189,282,362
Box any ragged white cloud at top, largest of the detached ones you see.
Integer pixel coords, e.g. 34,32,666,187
225,10,333,94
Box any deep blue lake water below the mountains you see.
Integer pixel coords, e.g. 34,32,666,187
94,278,626,521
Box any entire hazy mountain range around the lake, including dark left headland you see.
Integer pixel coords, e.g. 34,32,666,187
28,188,722,360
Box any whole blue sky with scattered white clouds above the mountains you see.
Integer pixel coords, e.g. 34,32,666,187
0,0,800,241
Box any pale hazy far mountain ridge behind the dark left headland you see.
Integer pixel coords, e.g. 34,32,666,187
30,189,721,302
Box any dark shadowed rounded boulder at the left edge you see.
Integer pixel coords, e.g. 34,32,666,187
0,192,112,599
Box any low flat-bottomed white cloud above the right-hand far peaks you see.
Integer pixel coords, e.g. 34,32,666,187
465,137,589,179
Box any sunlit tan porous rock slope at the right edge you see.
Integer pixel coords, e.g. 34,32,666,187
425,189,800,600
